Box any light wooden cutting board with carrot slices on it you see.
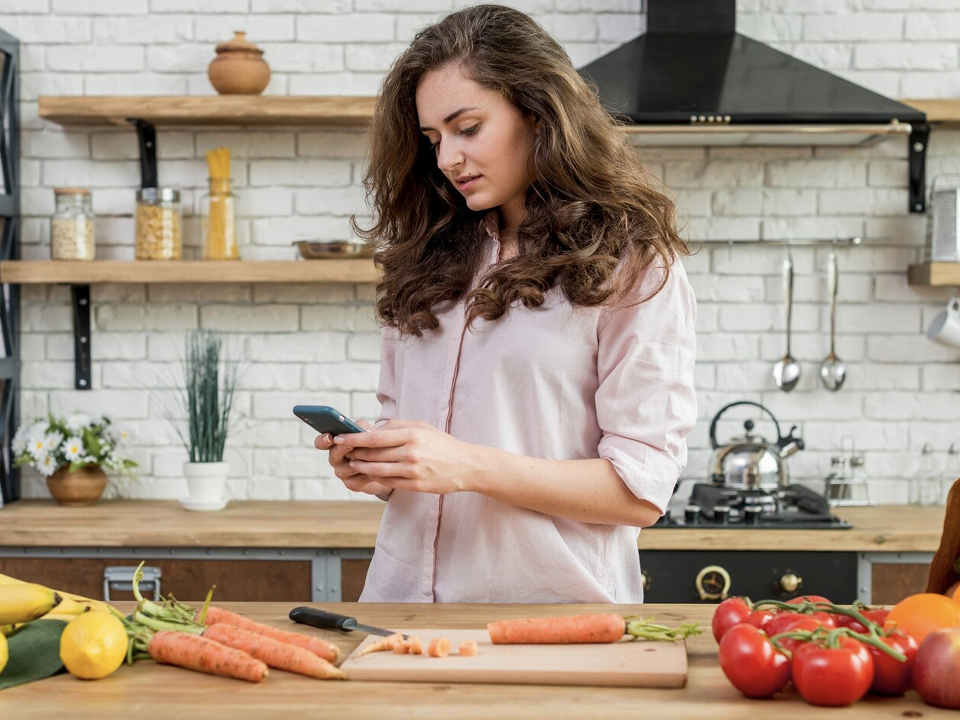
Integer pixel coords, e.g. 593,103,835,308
340,629,687,688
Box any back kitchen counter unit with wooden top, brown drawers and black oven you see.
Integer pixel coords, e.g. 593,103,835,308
0,500,944,603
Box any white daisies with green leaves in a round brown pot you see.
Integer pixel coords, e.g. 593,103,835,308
12,413,137,507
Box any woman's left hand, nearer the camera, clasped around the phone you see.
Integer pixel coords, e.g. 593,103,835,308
330,420,483,495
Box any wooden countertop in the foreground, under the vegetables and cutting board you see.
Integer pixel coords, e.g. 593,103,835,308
0,603,956,720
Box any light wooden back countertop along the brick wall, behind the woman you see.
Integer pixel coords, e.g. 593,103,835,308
0,500,944,553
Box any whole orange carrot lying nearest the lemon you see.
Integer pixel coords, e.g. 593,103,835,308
147,630,270,682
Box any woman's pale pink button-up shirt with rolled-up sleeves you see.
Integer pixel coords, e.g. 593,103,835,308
360,219,696,603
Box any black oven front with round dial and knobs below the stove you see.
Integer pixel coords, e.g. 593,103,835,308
640,550,857,603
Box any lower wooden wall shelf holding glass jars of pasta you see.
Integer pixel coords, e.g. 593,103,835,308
0,259,378,285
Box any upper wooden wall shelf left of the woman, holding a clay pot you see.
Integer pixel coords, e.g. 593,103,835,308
39,95,375,127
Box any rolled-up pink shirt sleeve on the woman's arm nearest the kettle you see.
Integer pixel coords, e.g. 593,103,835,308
596,262,697,513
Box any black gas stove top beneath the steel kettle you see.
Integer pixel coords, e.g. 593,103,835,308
653,483,851,530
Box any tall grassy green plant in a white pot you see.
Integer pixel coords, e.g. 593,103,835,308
174,330,239,510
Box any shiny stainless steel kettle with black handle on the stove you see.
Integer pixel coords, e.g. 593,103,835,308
710,400,803,490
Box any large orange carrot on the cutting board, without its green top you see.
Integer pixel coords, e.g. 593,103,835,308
487,613,627,645
